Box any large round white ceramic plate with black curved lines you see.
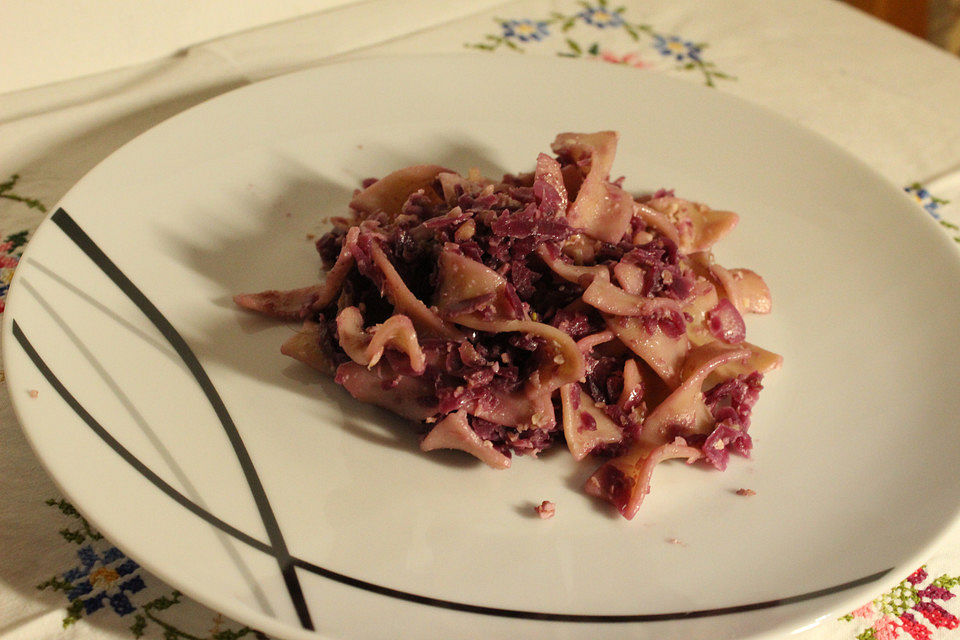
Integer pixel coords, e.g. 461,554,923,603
3,55,960,640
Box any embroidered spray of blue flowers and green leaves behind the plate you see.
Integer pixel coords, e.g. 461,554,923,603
466,0,732,87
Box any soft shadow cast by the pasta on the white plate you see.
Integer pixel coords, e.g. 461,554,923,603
174,145,504,468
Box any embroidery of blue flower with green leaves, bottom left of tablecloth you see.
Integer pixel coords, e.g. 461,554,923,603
37,499,268,640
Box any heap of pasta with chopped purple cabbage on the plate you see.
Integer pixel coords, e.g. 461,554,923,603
235,131,781,519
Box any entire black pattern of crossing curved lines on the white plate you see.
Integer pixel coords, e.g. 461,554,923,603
12,209,893,630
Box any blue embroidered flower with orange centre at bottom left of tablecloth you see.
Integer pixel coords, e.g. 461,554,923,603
63,545,147,616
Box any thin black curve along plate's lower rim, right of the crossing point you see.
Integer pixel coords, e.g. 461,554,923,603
294,558,893,623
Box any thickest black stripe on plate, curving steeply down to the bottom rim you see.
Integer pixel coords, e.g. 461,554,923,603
51,208,314,630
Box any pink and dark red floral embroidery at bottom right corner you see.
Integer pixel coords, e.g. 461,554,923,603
840,567,960,640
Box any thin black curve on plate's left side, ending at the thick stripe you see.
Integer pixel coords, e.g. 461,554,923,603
12,320,273,555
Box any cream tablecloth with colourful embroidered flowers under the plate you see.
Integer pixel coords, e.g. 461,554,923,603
0,0,960,640
